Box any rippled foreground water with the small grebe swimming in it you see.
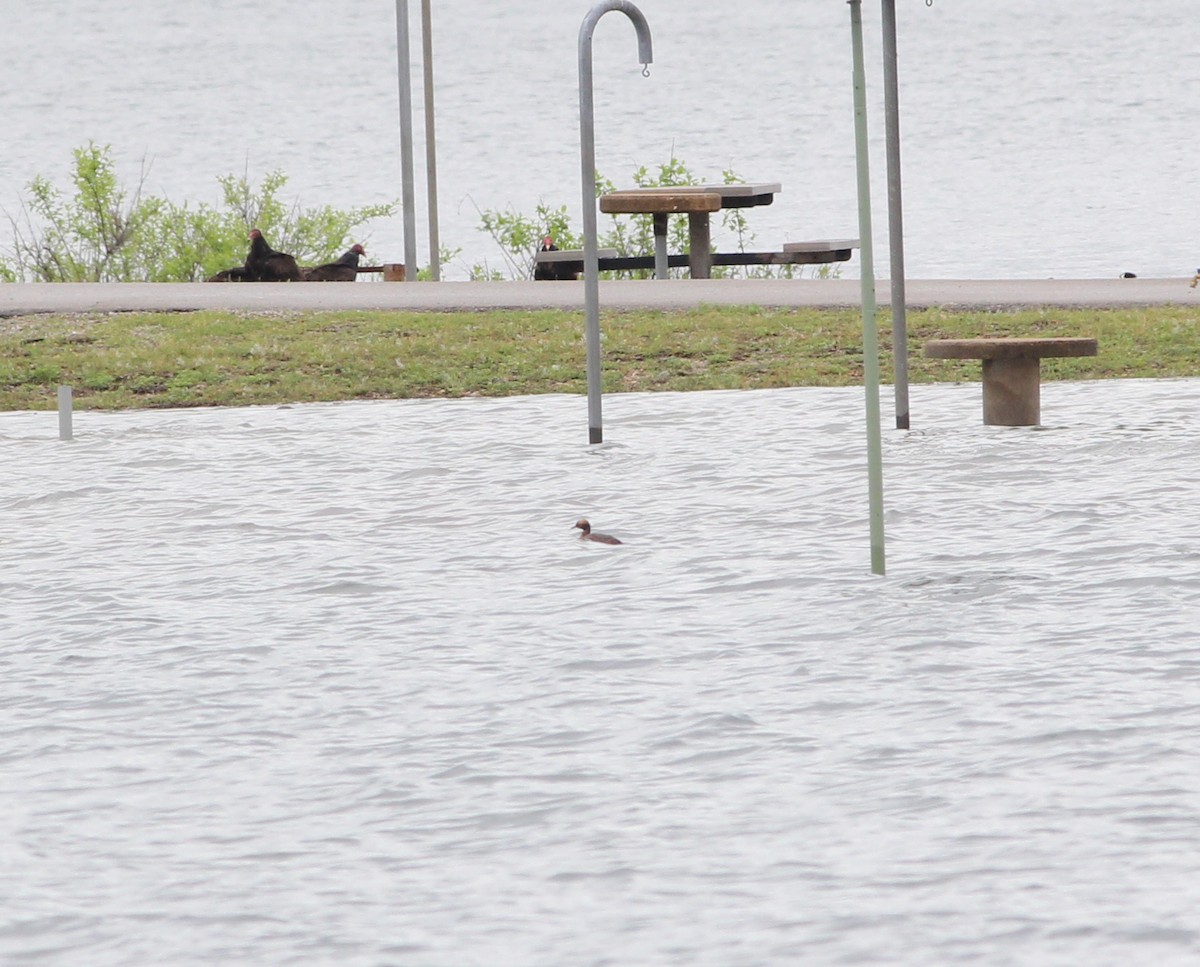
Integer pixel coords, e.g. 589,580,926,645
0,380,1200,967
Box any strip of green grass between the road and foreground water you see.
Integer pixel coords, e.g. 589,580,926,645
0,307,1200,409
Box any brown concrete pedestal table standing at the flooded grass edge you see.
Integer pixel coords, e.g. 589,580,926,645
925,337,1098,426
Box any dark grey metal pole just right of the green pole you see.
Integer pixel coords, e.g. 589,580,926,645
882,0,908,430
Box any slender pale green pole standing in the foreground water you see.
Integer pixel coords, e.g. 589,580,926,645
848,0,886,575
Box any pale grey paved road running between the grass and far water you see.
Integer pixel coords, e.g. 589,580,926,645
0,278,1200,317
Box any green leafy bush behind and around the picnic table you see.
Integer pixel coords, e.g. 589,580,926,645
472,156,839,278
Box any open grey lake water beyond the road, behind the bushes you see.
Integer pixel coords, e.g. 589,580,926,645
0,0,1200,278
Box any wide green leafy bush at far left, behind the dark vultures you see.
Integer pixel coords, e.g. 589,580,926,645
0,143,398,282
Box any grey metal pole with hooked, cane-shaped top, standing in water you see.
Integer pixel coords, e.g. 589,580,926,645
580,0,654,443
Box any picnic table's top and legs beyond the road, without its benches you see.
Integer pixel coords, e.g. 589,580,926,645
600,181,782,278
